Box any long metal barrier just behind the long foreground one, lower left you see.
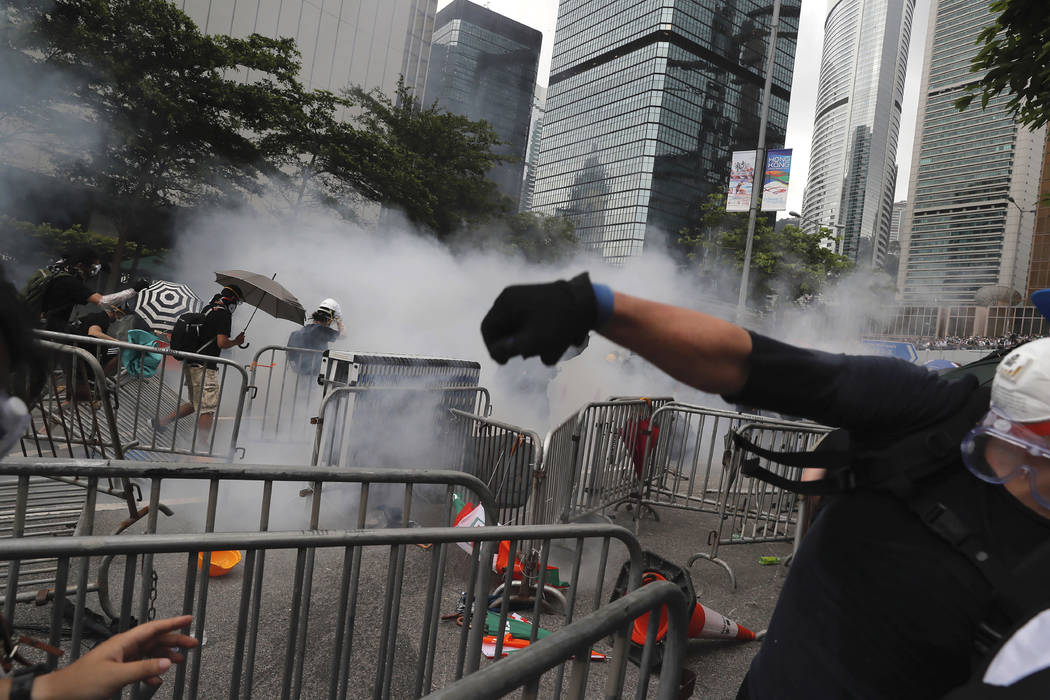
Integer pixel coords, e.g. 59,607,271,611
0,458,496,619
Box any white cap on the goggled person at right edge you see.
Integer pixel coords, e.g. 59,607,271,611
991,338,1050,423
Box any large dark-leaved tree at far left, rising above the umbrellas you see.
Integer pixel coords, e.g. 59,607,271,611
22,0,300,282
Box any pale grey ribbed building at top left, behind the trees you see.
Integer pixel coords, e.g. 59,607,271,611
172,0,438,98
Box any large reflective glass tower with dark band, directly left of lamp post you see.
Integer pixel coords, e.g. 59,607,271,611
532,0,799,262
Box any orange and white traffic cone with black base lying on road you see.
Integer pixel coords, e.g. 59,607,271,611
611,552,755,667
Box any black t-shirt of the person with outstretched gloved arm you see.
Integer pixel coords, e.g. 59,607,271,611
727,334,1050,700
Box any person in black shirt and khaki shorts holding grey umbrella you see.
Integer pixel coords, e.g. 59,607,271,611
150,284,245,443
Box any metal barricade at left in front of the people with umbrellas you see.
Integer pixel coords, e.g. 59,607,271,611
28,331,251,461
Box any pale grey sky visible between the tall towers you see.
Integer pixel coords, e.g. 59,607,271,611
438,0,929,211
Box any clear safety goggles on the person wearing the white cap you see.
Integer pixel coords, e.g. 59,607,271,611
962,409,1050,509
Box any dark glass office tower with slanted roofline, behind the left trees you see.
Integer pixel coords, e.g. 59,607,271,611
425,0,543,204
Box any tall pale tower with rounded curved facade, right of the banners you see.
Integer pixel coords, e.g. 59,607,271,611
802,0,915,268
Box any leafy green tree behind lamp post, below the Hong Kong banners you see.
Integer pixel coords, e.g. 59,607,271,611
678,194,854,300
